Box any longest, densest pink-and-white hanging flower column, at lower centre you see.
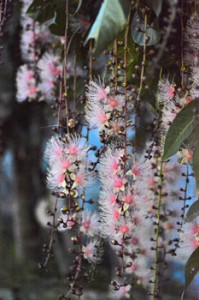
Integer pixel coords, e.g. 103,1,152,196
99,149,153,292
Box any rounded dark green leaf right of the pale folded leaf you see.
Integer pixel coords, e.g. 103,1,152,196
131,12,161,46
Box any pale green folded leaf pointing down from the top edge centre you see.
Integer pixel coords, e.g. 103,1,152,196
85,0,130,55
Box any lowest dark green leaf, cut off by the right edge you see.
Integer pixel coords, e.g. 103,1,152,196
185,247,199,290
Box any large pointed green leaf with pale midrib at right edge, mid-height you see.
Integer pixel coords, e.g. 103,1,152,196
163,99,199,159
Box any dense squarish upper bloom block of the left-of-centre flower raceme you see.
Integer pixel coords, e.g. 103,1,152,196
45,135,89,197
